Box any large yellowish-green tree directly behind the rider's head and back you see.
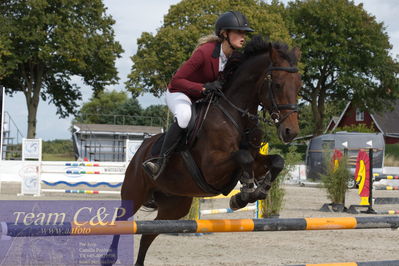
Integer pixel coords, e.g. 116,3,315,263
126,0,290,96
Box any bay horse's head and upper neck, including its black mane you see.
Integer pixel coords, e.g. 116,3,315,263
223,36,301,142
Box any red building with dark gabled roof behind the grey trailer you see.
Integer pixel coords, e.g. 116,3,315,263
325,100,399,144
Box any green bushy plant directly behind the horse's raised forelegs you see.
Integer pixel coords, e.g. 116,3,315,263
262,145,302,218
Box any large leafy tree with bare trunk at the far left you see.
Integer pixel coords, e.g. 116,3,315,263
0,0,123,138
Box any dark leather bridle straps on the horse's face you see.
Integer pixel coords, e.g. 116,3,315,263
259,65,298,126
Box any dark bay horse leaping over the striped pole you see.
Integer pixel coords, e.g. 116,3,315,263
101,36,301,265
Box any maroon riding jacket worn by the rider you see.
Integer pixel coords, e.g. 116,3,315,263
168,42,221,101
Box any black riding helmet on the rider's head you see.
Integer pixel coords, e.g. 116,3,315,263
215,11,254,36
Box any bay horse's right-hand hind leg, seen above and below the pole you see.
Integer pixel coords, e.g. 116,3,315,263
135,194,193,266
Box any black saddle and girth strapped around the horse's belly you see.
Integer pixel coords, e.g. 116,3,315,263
151,101,241,196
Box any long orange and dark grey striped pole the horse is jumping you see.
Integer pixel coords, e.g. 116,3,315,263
0,216,399,237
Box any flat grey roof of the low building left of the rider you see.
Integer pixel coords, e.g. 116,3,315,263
73,124,163,135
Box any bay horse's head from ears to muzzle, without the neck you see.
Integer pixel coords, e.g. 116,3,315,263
258,39,301,142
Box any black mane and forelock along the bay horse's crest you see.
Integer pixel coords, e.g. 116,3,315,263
223,35,298,84
